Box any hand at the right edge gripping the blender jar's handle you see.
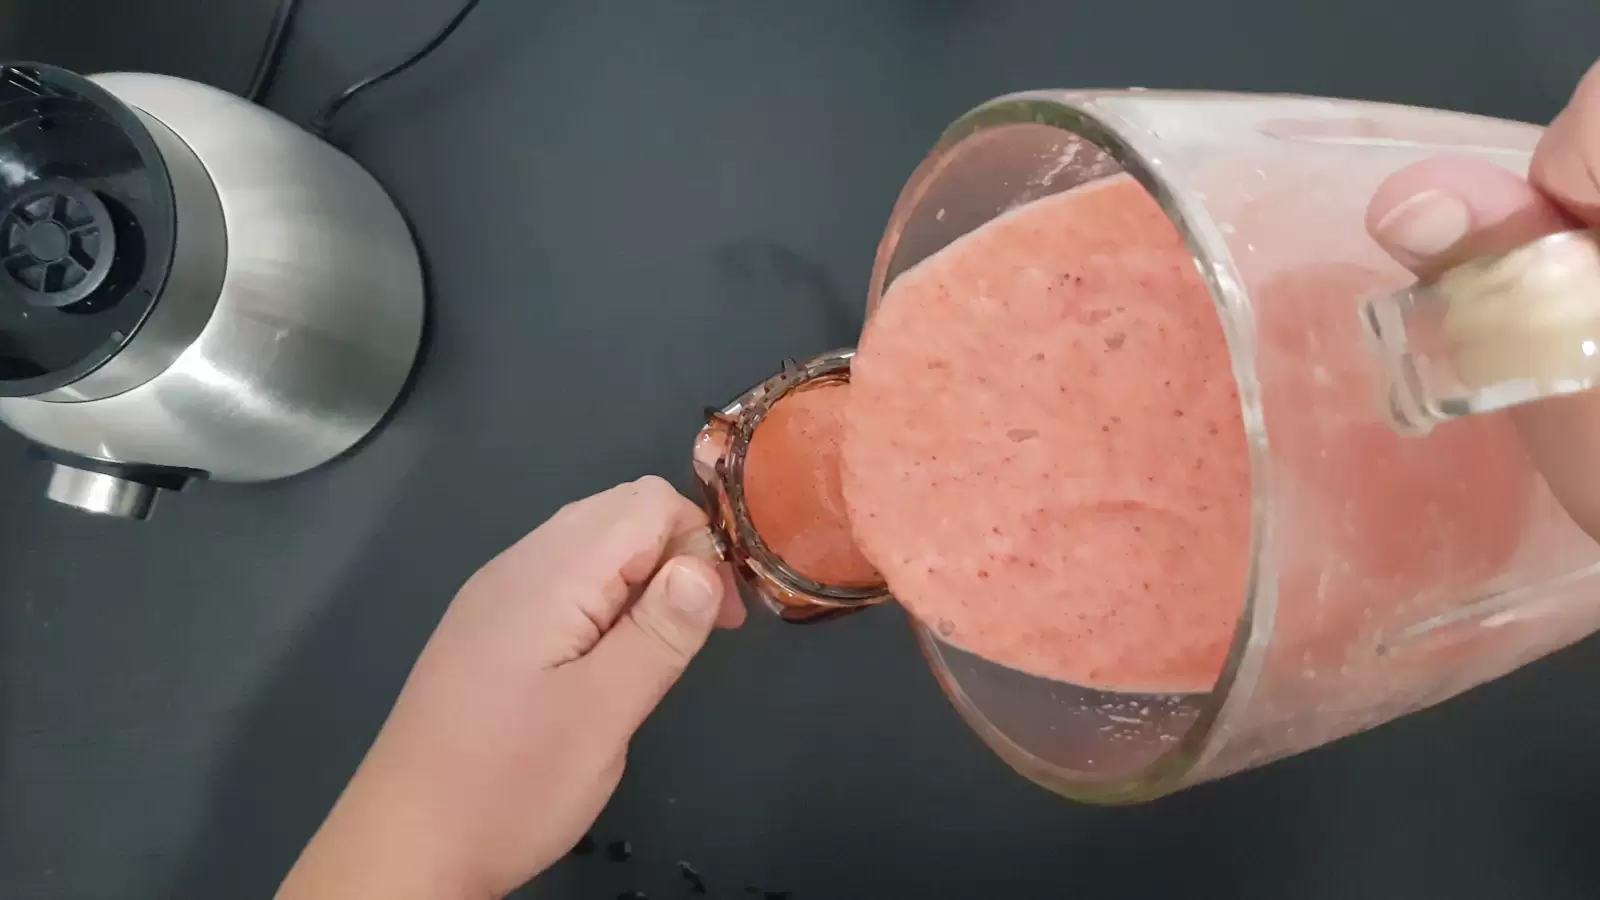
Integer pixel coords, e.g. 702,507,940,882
1366,64,1600,538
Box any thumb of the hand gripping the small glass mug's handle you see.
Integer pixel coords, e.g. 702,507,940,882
570,556,725,735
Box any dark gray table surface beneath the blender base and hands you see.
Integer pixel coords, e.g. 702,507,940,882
0,0,1600,900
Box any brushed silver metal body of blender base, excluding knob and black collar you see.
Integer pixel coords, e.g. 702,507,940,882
0,74,424,482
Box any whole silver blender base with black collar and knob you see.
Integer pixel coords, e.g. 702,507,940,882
0,64,424,519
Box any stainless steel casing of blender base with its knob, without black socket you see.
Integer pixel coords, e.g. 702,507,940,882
0,67,424,517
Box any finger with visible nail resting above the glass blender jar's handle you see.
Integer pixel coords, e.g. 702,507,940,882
1366,157,1573,279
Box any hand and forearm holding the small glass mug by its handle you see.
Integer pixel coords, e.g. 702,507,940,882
278,477,744,900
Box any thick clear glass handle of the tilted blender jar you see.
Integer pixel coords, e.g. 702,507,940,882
1362,231,1600,434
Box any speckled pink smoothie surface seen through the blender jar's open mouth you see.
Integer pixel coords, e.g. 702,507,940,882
842,176,1251,692
